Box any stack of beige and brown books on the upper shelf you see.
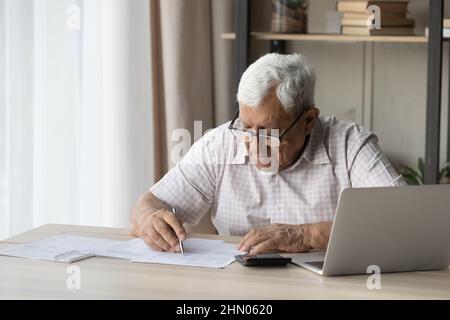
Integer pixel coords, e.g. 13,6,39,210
337,0,414,35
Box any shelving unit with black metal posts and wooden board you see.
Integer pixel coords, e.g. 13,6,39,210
229,0,450,184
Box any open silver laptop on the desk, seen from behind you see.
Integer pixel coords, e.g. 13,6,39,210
292,185,450,276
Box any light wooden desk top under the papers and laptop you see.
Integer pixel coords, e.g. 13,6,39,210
0,225,450,299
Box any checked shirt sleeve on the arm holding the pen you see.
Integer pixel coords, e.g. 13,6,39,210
150,137,216,225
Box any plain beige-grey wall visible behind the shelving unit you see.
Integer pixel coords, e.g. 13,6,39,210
252,0,450,166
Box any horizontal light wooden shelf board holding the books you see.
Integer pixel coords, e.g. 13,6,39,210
222,32,428,43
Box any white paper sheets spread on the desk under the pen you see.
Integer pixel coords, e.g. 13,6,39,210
0,234,241,268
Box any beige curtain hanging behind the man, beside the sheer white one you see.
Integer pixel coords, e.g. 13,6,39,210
150,0,234,180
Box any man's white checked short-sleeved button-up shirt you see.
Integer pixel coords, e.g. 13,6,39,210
151,117,405,235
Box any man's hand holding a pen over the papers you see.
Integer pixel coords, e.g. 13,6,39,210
132,209,186,252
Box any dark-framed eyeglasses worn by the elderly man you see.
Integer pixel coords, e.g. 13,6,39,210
228,106,308,146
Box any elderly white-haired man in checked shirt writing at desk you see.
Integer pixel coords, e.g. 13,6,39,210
132,54,404,254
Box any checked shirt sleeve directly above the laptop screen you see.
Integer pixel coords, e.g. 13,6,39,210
349,134,406,188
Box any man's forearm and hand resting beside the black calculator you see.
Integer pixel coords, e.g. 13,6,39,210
237,222,332,254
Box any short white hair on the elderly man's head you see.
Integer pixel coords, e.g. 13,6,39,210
237,53,316,113
